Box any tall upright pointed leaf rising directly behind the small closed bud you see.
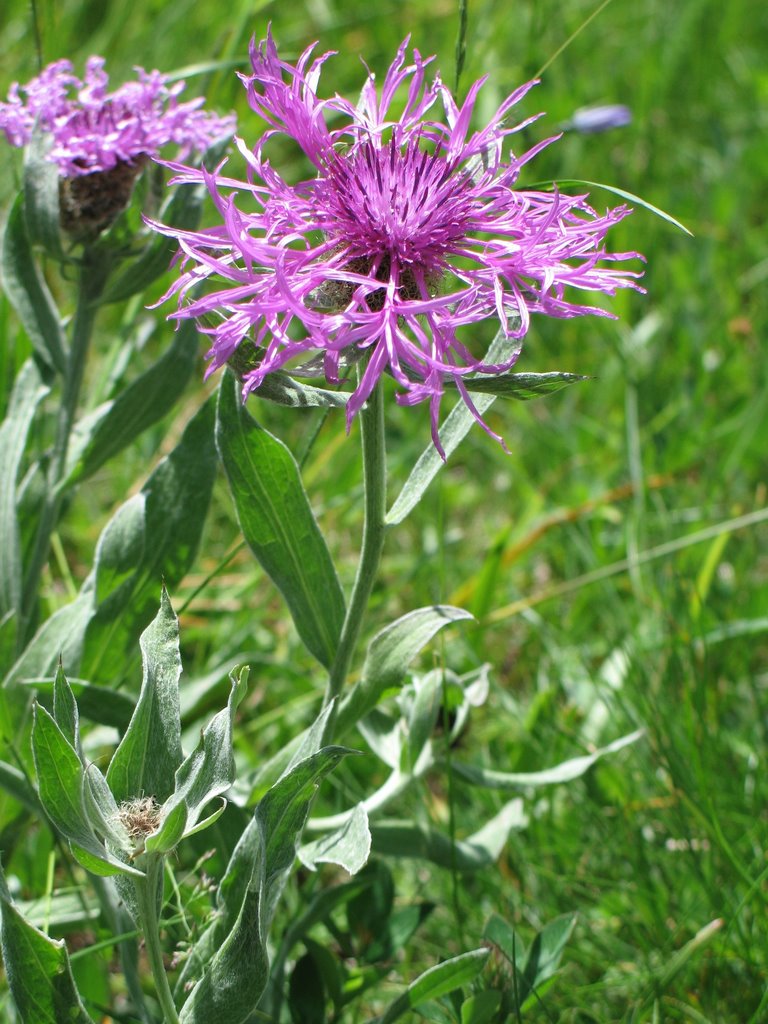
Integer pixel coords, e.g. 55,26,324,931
106,587,183,804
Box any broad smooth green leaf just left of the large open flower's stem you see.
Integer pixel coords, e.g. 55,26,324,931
216,373,344,668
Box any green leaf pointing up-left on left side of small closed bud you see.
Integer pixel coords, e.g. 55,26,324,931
32,705,141,878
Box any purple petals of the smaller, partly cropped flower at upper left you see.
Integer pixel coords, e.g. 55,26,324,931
0,56,234,178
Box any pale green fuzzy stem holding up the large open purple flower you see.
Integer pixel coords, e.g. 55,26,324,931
324,384,387,743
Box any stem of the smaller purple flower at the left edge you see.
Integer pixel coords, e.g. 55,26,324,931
18,249,110,649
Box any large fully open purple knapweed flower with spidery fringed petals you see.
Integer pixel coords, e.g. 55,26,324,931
154,35,640,454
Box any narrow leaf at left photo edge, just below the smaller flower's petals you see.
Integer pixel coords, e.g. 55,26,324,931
0,196,67,374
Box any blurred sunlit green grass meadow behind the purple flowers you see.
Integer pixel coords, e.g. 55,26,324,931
0,0,768,1024
